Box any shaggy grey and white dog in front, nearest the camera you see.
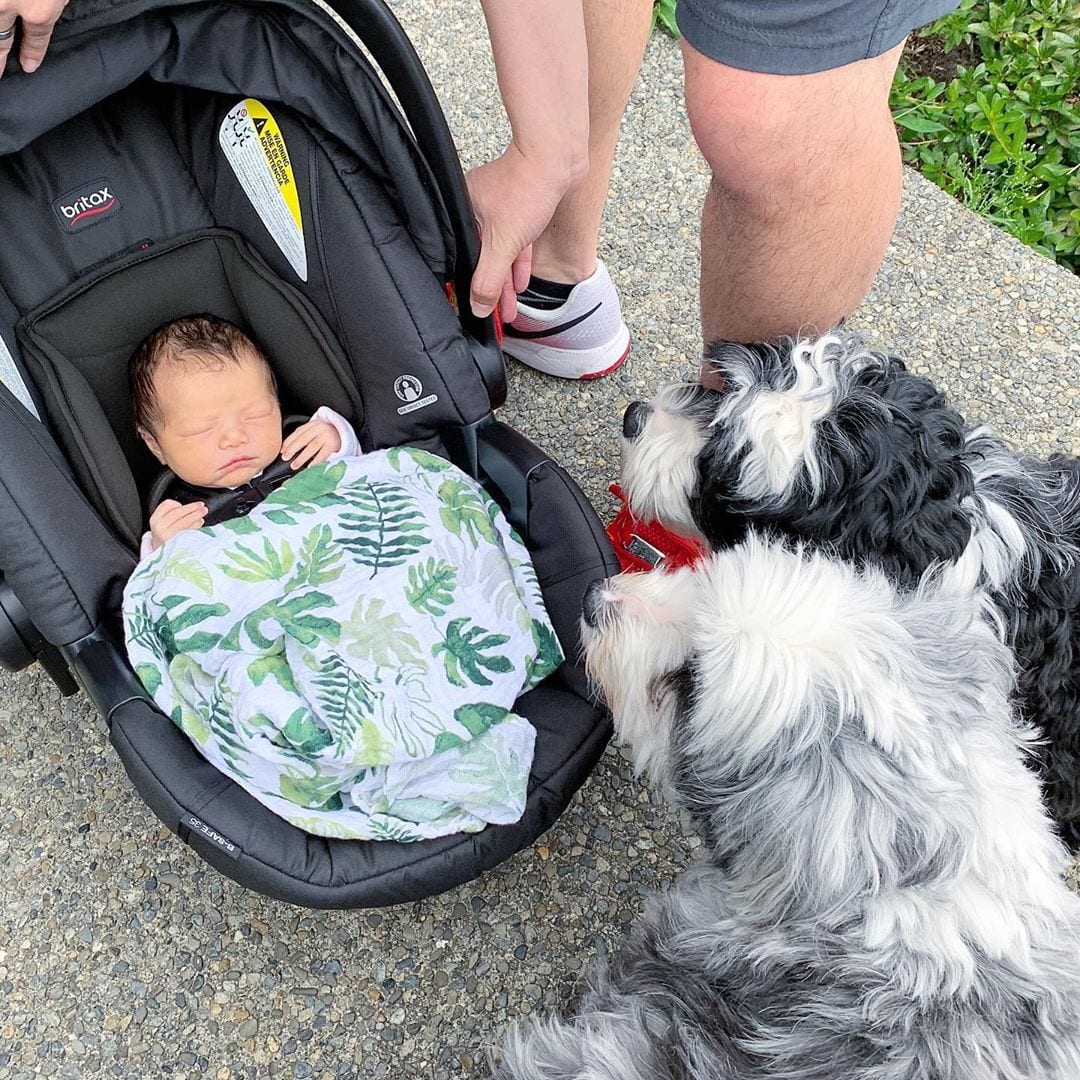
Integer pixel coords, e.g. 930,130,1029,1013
496,538,1080,1080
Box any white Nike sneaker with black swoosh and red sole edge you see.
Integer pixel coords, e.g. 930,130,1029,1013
502,259,630,379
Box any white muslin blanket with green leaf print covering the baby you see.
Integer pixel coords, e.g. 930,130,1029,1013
124,448,563,840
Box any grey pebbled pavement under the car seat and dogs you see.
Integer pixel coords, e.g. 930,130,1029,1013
0,0,1080,1080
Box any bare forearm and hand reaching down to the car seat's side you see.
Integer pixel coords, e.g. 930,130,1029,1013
465,0,589,321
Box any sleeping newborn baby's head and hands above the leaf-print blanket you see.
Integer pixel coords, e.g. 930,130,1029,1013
131,315,360,548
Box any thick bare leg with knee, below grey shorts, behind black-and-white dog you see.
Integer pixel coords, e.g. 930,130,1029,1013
683,41,902,343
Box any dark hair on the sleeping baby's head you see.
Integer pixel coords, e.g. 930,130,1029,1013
127,315,278,434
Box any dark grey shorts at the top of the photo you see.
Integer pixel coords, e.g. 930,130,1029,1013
675,0,959,75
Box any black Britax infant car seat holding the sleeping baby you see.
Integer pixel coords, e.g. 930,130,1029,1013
0,0,617,907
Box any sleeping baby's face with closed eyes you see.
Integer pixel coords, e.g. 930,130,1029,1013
143,347,282,487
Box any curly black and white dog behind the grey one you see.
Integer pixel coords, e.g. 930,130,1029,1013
622,335,1080,850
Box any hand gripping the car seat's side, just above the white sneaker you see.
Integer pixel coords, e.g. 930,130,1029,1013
465,143,571,323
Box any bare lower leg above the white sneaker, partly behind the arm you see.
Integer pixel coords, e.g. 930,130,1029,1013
532,0,652,284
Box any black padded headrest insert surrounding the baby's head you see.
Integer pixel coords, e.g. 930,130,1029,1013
17,229,362,544
